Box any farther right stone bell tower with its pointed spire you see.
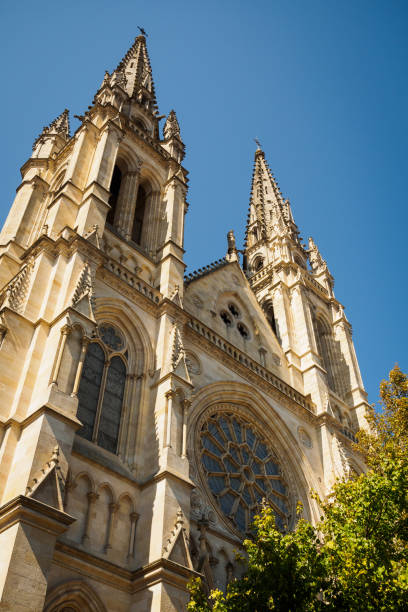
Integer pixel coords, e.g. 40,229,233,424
244,146,367,482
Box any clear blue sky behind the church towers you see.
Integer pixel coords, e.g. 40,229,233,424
0,0,408,402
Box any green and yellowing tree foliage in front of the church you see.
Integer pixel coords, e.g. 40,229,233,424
188,367,408,612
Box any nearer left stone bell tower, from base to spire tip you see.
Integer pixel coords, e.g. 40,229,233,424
0,36,196,612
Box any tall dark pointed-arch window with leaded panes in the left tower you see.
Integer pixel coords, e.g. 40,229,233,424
77,324,127,453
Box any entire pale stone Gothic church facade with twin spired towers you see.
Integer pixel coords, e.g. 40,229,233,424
0,36,366,612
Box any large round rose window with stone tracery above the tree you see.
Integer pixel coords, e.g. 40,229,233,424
200,412,290,533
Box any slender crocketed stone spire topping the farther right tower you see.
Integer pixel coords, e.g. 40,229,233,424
245,143,299,247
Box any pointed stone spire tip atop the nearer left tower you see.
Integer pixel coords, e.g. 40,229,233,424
112,36,157,113
